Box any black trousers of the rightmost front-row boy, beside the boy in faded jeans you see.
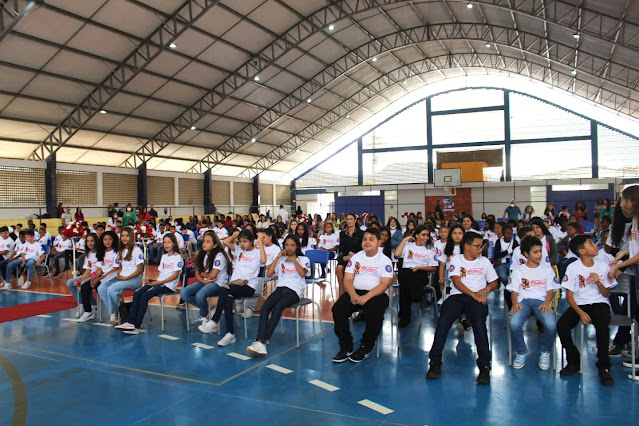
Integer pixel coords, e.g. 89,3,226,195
557,303,610,369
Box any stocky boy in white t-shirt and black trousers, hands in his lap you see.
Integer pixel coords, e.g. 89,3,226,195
332,228,393,363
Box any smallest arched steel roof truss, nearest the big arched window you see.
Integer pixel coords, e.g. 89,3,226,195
238,53,639,177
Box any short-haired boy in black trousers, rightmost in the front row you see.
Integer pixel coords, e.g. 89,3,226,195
557,235,617,386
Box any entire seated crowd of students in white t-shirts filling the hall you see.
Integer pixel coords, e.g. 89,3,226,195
0,191,639,386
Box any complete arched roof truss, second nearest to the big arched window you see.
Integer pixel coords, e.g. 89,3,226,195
189,23,639,173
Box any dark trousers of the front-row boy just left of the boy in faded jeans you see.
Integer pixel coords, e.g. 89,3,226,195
428,294,490,368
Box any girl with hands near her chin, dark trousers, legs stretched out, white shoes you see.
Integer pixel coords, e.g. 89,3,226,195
246,235,311,356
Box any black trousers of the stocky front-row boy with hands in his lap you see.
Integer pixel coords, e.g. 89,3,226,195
333,290,388,352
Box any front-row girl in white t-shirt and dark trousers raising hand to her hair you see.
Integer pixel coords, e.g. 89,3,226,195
198,229,266,346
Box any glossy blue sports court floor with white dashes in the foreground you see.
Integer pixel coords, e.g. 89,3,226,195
0,291,639,425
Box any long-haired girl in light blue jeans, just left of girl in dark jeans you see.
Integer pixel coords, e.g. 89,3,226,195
98,227,144,325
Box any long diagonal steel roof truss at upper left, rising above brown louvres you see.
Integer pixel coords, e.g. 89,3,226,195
29,0,220,161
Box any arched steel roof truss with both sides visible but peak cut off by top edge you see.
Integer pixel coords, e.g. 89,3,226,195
122,0,639,167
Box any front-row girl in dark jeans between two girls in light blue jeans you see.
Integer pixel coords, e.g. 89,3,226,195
115,233,184,334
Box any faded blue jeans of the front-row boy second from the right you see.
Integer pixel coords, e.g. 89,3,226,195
510,299,557,355
